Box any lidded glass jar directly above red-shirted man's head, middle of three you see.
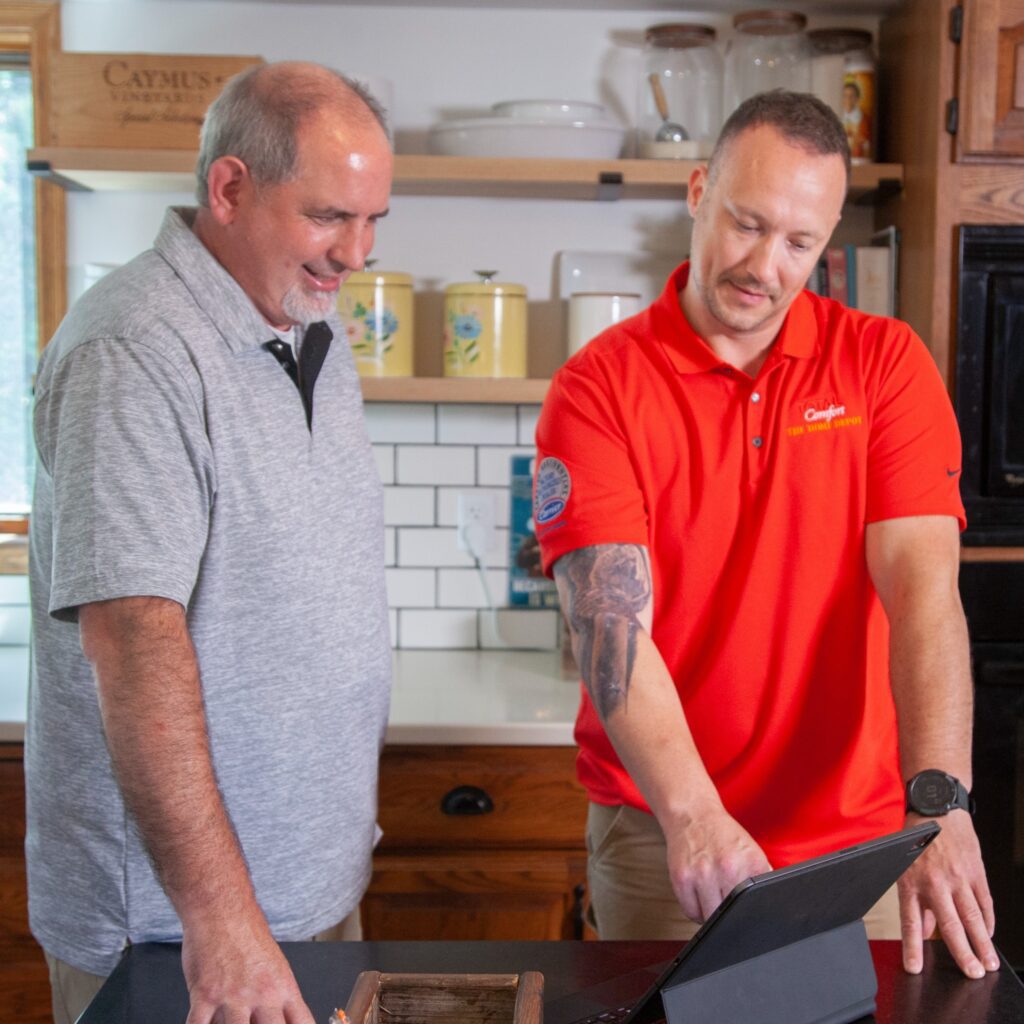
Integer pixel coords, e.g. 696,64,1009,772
724,10,811,117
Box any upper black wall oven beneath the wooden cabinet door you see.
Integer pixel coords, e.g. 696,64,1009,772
954,224,1024,545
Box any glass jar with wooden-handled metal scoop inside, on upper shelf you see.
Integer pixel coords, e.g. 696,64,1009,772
637,24,722,158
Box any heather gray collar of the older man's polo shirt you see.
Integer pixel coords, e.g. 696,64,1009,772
153,207,273,353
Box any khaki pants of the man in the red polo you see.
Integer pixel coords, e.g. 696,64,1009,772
587,804,900,939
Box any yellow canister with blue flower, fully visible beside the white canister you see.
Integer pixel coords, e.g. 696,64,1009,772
444,270,526,377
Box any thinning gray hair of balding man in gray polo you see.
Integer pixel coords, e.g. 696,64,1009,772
196,63,388,207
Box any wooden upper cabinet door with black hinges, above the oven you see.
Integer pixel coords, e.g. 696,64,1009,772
956,0,1024,160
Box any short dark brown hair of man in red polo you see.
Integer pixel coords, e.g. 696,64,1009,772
708,89,850,188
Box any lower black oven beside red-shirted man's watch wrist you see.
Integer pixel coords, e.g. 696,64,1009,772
961,562,1024,971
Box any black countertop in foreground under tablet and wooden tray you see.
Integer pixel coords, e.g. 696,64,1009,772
79,942,1024,1024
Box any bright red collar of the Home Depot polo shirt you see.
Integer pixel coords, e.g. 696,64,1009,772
650,260,818,374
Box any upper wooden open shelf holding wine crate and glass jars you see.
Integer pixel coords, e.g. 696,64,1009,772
28,146,903,203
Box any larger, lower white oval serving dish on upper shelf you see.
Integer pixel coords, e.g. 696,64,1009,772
427,117,626,160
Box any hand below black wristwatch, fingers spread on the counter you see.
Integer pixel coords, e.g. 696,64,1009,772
899,810,999,978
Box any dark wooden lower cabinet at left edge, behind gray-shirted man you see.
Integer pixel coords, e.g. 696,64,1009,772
0,743,53,1024
